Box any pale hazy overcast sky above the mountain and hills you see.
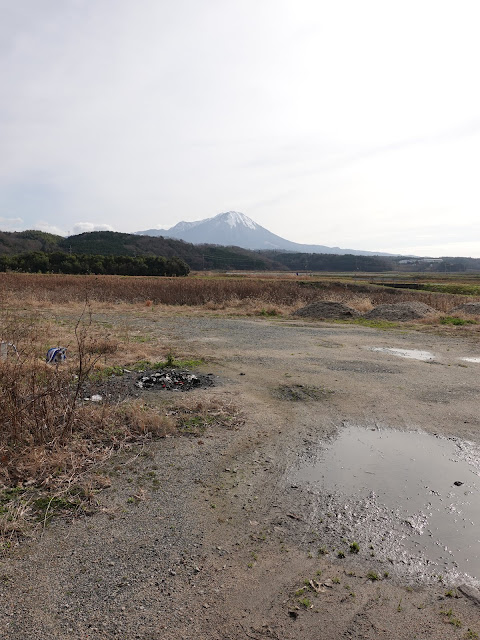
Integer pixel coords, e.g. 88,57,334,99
0,0,480,257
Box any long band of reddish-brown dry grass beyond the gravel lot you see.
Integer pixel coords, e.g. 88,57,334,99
0,273,480,315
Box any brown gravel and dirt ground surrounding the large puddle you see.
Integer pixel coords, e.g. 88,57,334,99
0,312,480,640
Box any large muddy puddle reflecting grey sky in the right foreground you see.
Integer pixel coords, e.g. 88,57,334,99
294,425,480,580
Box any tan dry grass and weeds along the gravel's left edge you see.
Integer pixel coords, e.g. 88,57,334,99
0,305,241,552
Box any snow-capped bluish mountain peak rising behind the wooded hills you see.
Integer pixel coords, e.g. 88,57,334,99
135,211,387,255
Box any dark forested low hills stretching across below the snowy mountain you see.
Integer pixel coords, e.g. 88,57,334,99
0,230,480,275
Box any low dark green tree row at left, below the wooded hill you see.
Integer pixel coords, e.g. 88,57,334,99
0,251,190,276
